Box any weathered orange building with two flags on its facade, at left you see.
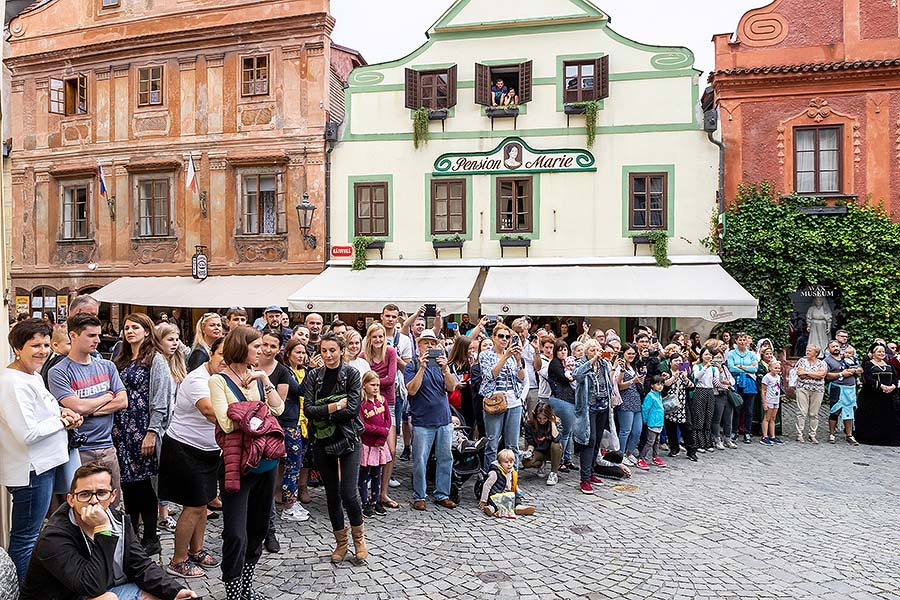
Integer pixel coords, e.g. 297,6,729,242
4,0,362,318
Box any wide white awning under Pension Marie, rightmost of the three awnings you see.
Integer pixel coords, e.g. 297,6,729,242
481,264,758,322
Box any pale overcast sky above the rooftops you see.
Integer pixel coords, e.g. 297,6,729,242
331,0,768,77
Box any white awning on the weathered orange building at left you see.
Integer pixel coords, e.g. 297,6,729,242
91,275,315,308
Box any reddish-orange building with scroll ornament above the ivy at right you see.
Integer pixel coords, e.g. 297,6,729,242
711,0,900,213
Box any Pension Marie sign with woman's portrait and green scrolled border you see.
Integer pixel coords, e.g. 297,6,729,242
433,137,597,176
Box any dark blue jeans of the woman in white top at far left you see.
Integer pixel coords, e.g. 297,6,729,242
7,468,56,582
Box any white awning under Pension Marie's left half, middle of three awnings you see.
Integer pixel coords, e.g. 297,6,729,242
288,267,481,314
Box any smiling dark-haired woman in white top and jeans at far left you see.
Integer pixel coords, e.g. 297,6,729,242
0,319,83,581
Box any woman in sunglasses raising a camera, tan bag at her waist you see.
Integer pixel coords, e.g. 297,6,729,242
479,323,525,465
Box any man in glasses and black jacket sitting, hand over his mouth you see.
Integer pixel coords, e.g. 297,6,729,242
19,463,197,600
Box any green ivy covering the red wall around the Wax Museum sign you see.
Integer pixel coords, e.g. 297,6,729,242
722,182,900,347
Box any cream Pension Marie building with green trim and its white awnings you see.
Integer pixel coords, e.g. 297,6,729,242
294,0,756,328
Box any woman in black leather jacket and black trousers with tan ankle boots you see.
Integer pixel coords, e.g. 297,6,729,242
301,329,362,563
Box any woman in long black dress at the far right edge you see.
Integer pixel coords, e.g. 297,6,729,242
854,343,900,446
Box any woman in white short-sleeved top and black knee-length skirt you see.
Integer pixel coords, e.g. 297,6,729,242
157,338,225,578
